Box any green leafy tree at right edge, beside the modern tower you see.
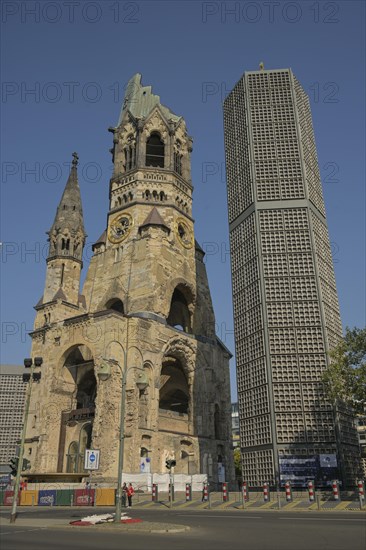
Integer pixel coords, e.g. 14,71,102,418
323,328,366,413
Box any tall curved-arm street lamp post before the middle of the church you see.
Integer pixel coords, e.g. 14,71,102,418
98,359,148,523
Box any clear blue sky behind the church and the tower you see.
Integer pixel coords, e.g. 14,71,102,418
1,0,365,397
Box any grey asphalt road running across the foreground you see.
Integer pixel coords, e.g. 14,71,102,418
0,508,366,550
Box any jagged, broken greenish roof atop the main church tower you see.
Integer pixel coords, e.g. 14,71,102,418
117,73,182,126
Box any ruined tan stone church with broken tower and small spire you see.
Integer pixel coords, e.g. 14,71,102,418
26,75,233,488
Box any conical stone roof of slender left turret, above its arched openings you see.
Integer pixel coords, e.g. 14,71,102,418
51,153,85,235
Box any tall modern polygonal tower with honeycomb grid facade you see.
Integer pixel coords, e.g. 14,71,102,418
224,69,358,485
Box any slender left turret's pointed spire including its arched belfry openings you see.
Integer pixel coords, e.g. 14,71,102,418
48,153,86,259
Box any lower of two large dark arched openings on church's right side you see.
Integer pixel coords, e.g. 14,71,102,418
159,357,189,414
